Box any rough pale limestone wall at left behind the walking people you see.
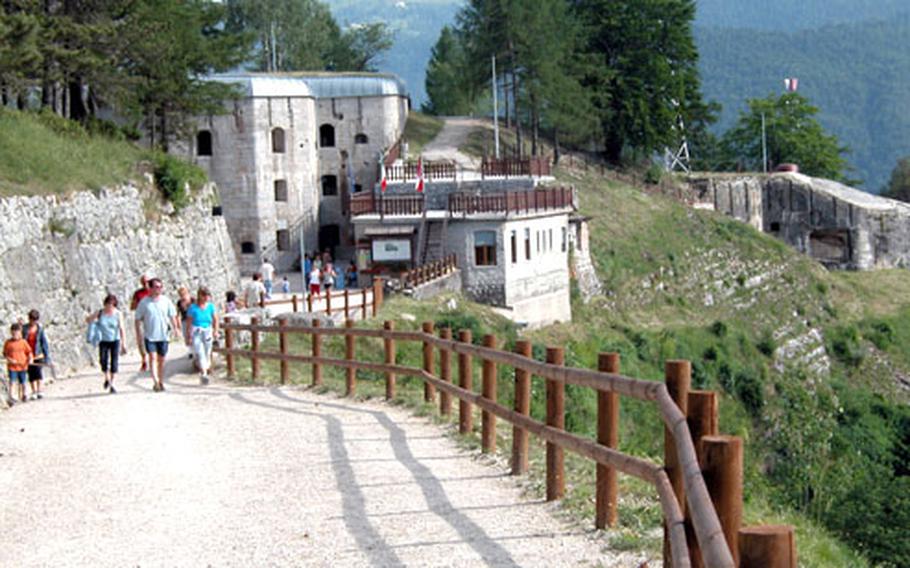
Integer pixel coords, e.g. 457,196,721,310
0,185,239,384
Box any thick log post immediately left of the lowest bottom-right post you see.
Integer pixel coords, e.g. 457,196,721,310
690,438,743,563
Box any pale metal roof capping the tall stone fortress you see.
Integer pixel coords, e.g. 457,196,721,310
209,72,407,99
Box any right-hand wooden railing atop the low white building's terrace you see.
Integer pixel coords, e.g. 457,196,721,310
449,187,574,215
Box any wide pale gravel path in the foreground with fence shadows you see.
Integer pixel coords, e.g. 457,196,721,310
0,344,636,567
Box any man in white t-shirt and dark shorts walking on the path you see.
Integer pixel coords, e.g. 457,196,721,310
136,278,180,391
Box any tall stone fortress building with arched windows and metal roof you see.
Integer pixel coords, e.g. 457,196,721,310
174,72,408,274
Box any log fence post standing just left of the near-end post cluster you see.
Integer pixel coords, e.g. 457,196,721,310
594,353,619,529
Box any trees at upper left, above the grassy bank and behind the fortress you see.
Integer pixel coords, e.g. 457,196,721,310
0,0,392,147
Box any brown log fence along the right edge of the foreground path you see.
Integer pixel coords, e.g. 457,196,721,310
217,319,796,568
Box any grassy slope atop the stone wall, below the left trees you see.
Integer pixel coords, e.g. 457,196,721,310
0,109,144,195
